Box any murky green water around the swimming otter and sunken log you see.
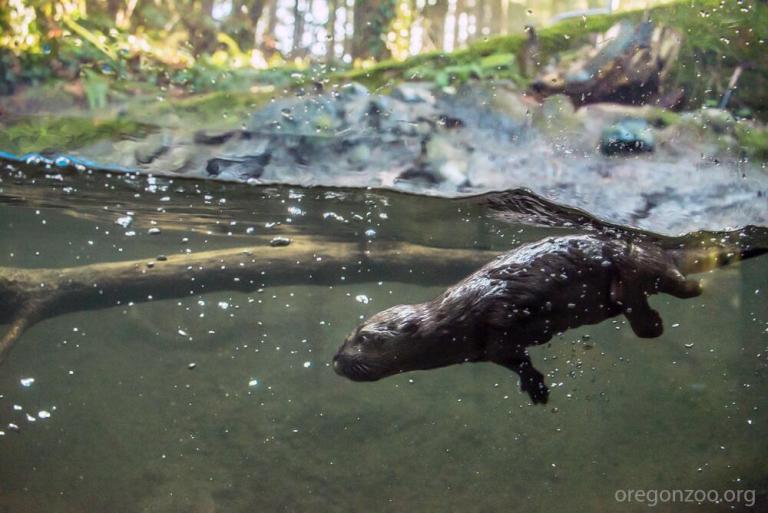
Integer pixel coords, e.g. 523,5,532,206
0,169,768,512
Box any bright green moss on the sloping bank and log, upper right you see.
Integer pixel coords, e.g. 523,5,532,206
336,0,768,117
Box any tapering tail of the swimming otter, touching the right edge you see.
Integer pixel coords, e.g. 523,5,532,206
662,225,768,275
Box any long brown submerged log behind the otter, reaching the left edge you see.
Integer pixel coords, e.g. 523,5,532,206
0,237,496,363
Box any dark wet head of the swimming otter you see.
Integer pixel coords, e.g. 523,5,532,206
333,304,448,381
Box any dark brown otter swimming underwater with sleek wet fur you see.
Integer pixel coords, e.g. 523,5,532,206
333,234,765,404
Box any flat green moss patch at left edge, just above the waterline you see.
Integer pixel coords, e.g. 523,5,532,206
0,117,152,154
